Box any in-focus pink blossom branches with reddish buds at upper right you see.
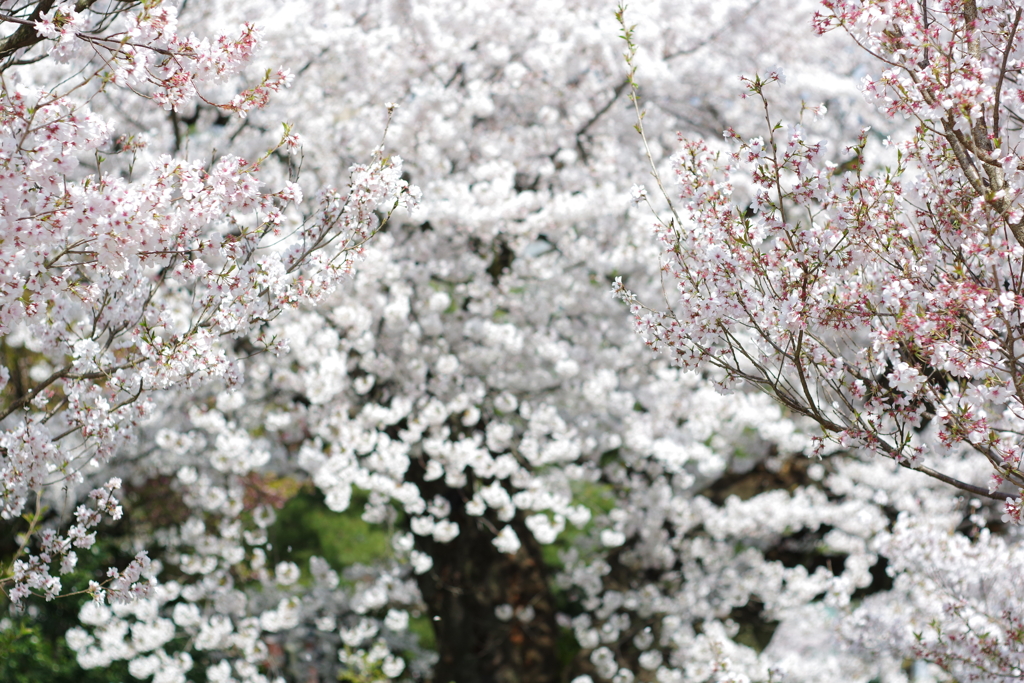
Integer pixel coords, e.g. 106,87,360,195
625,3,1024,517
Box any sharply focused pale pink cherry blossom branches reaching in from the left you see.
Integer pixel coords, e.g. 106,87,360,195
0,4,409,618
